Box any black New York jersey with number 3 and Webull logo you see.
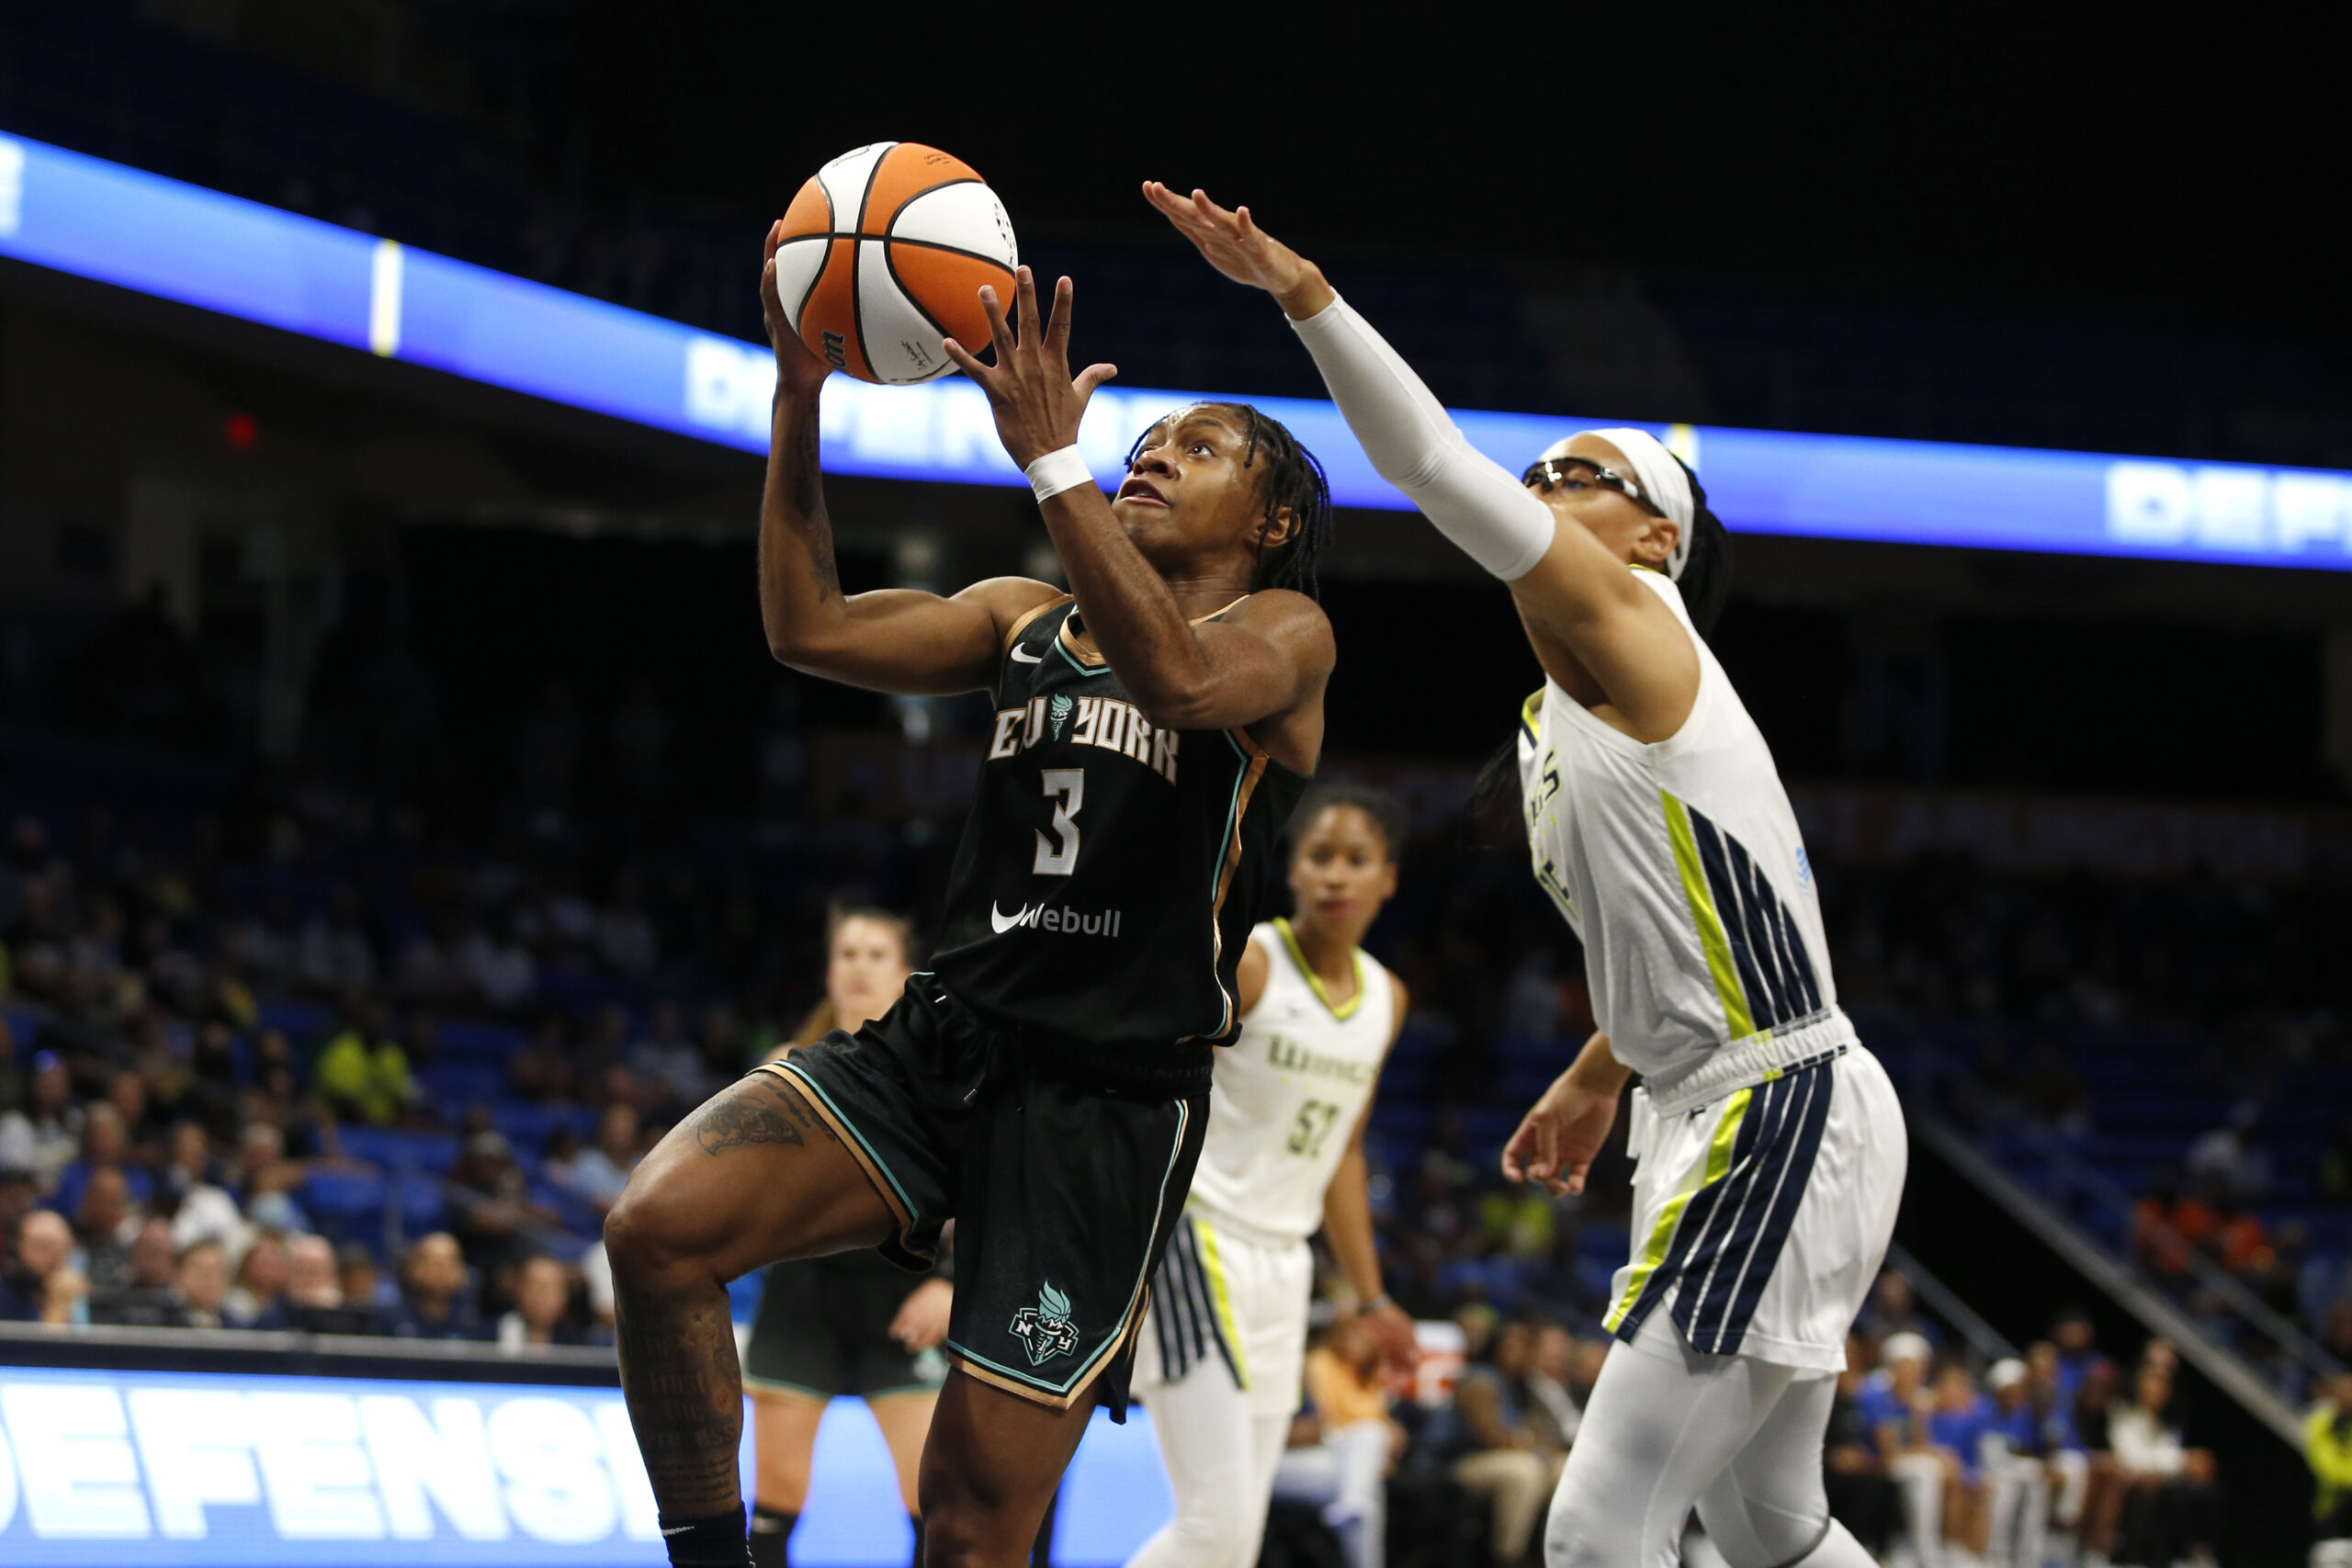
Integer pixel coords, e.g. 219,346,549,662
933,600,1306,1051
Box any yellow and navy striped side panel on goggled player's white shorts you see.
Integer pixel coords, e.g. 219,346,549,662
1601,1048,1844,1357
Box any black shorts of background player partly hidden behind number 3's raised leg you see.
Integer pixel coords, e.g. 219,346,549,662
743,1253,944,1399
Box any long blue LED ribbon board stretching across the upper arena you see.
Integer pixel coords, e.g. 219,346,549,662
0,139,2352,571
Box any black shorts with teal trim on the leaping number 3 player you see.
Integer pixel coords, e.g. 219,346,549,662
752,974,1209,1420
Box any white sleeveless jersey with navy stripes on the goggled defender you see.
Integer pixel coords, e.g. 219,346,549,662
1523,569,1851,1100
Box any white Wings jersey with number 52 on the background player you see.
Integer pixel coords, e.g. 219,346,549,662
1193,919,1397,1241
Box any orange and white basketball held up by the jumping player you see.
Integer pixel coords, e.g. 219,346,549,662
776,141,1018,386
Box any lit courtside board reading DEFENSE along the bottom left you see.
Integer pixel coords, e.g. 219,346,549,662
0,1366,1173,1568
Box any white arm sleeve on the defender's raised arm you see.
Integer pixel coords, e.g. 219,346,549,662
1291,299,1553,583
